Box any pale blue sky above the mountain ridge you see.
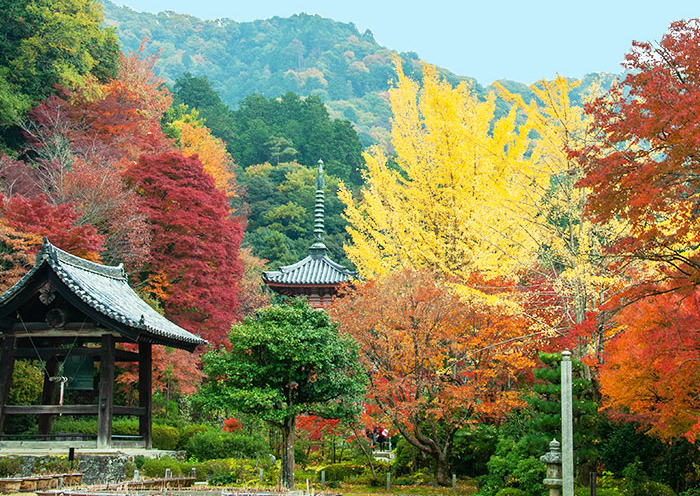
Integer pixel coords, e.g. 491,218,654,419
113,0,700,85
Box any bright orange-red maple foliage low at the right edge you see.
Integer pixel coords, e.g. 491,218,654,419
600,288,700,438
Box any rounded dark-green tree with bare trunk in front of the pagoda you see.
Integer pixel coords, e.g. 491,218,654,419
200,298,366,489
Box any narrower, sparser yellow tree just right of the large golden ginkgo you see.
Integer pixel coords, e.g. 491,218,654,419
499,77,623,327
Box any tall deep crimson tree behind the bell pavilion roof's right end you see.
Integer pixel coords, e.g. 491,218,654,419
126,152,243,346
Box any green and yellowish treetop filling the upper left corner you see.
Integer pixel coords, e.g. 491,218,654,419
0,0,119,143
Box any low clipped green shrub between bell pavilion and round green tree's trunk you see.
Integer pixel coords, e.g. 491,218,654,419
185,429,268,460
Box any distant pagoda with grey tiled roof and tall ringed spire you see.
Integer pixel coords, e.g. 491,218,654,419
262,160,357,308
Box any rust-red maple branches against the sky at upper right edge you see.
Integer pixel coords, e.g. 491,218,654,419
574,19,700,281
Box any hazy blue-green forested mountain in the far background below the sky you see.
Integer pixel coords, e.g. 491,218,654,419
104,0,611,146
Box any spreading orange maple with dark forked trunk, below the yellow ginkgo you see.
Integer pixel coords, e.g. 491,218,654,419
331,271,530,484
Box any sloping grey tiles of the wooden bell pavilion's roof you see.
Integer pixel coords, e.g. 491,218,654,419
0,239,206,349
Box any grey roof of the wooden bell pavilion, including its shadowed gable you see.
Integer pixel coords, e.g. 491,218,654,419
0,238,206,351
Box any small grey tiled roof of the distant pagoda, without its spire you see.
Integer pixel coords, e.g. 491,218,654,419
263,252,357,286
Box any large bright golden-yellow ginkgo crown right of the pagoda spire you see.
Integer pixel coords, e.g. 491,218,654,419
340,59,547,279
